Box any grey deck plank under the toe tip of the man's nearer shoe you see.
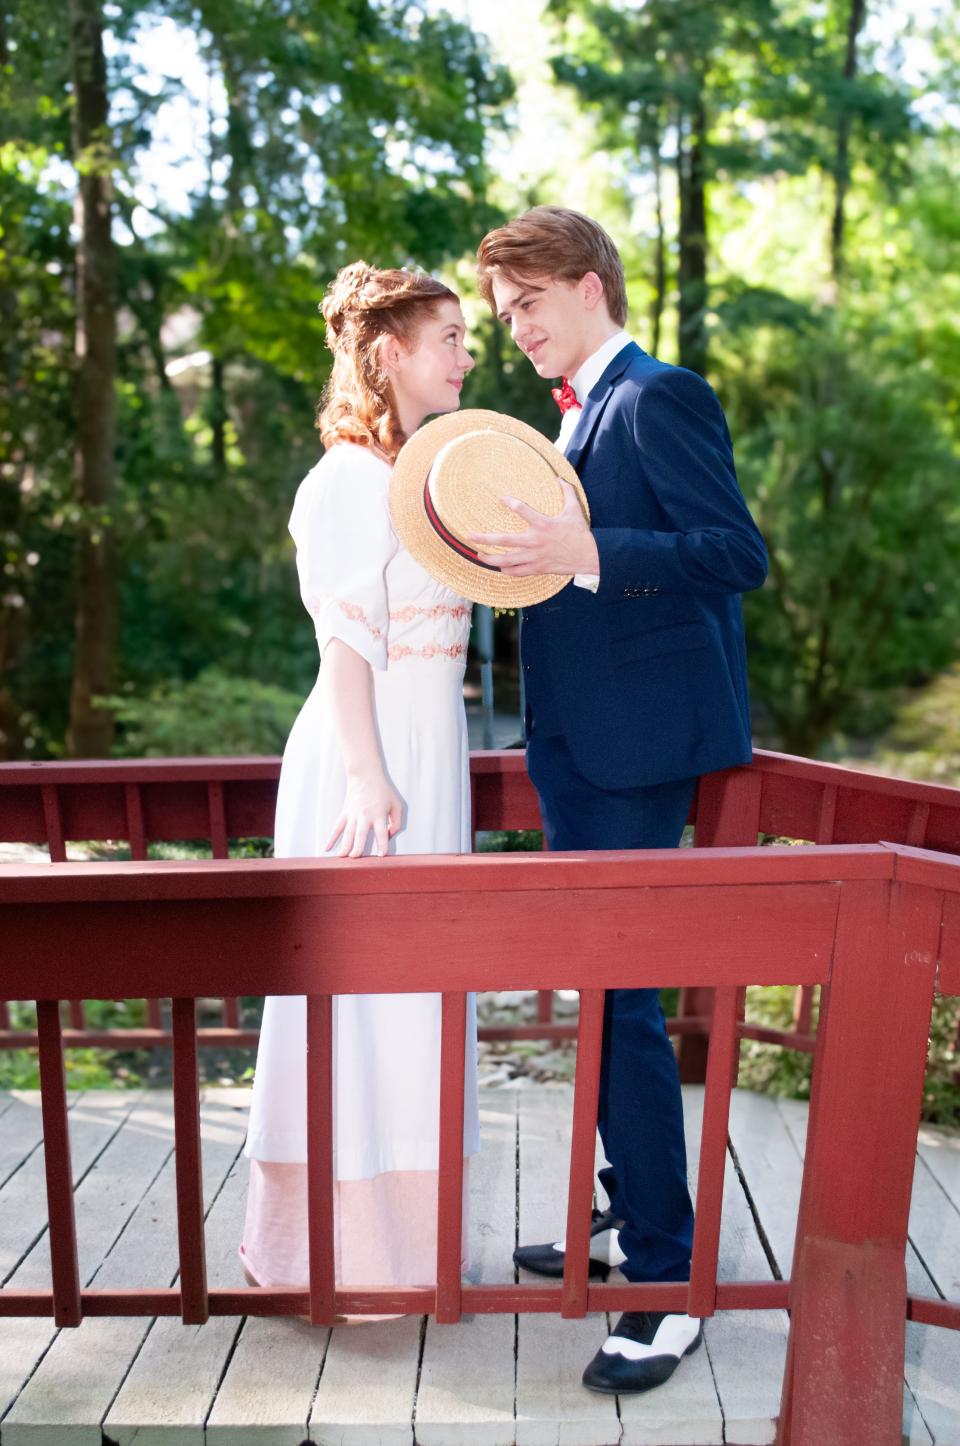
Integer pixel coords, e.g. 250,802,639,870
516,1085,620,1446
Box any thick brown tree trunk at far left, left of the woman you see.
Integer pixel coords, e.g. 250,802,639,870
67,0,117,758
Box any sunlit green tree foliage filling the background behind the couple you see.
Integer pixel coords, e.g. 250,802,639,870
0,0,960,756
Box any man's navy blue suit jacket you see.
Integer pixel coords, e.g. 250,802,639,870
520,343,766,790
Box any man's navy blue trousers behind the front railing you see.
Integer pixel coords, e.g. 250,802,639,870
526,729,697,1281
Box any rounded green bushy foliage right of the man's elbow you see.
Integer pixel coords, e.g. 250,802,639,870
724,318,960,756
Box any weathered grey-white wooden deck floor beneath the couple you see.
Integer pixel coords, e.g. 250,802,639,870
0,1085,960,1446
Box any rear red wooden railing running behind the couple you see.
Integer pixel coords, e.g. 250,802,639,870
0,750,960,1082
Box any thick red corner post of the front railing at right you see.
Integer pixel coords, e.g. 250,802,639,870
776,879,943,1446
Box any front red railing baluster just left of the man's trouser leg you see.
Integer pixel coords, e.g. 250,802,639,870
561,989,604,1319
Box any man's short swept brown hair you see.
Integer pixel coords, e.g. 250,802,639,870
477,205,626,327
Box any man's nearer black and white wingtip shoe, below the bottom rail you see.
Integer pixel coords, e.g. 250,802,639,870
583,1310,703,1395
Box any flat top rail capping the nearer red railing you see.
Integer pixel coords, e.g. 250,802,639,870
0,843,907,904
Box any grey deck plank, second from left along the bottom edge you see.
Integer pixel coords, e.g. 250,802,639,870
101,1141,247,1446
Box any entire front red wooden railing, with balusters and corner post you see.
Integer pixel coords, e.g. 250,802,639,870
0,838,960,1446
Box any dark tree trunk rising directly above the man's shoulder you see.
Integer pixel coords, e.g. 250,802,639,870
677,90,707,376
